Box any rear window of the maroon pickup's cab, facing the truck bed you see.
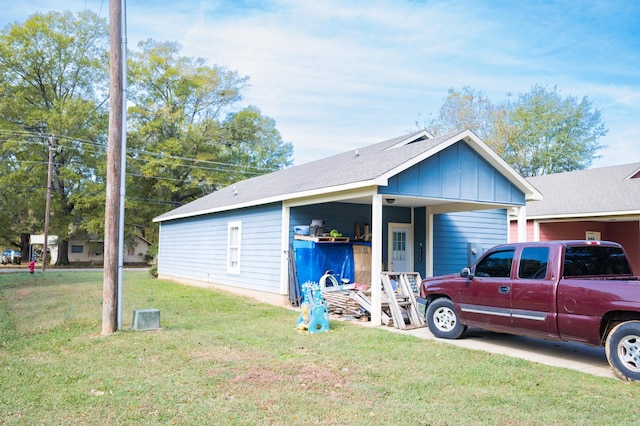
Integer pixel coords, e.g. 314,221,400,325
563,245,631,277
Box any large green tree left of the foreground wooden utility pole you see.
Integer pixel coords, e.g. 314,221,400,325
0,11,109,264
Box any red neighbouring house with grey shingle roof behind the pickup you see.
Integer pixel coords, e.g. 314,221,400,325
511,163,640,274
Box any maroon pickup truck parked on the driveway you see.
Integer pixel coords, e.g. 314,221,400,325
420,241,640,381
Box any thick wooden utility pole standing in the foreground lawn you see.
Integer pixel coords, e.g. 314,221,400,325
102,0,125,335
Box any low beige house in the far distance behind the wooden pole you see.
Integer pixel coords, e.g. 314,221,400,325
31,235,151,263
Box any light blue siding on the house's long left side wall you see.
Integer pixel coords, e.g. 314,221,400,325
158,203,282,293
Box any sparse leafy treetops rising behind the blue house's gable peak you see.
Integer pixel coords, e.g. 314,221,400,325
422,86,607,177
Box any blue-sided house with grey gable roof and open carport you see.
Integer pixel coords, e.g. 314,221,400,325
154,130,541,324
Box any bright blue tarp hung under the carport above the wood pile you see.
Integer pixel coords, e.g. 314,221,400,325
293,240,354,286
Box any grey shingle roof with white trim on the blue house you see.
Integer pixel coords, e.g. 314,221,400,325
154,130,540,222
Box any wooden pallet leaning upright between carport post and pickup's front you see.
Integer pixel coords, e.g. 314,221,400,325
380,272,425,330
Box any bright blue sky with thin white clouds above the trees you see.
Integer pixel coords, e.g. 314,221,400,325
0,0,640,167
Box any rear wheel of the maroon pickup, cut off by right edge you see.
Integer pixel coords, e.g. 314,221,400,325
605,321,640,381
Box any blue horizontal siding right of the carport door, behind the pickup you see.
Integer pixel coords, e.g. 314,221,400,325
433,209,507,275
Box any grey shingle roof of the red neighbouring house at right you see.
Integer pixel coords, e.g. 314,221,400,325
527,163,640,219
